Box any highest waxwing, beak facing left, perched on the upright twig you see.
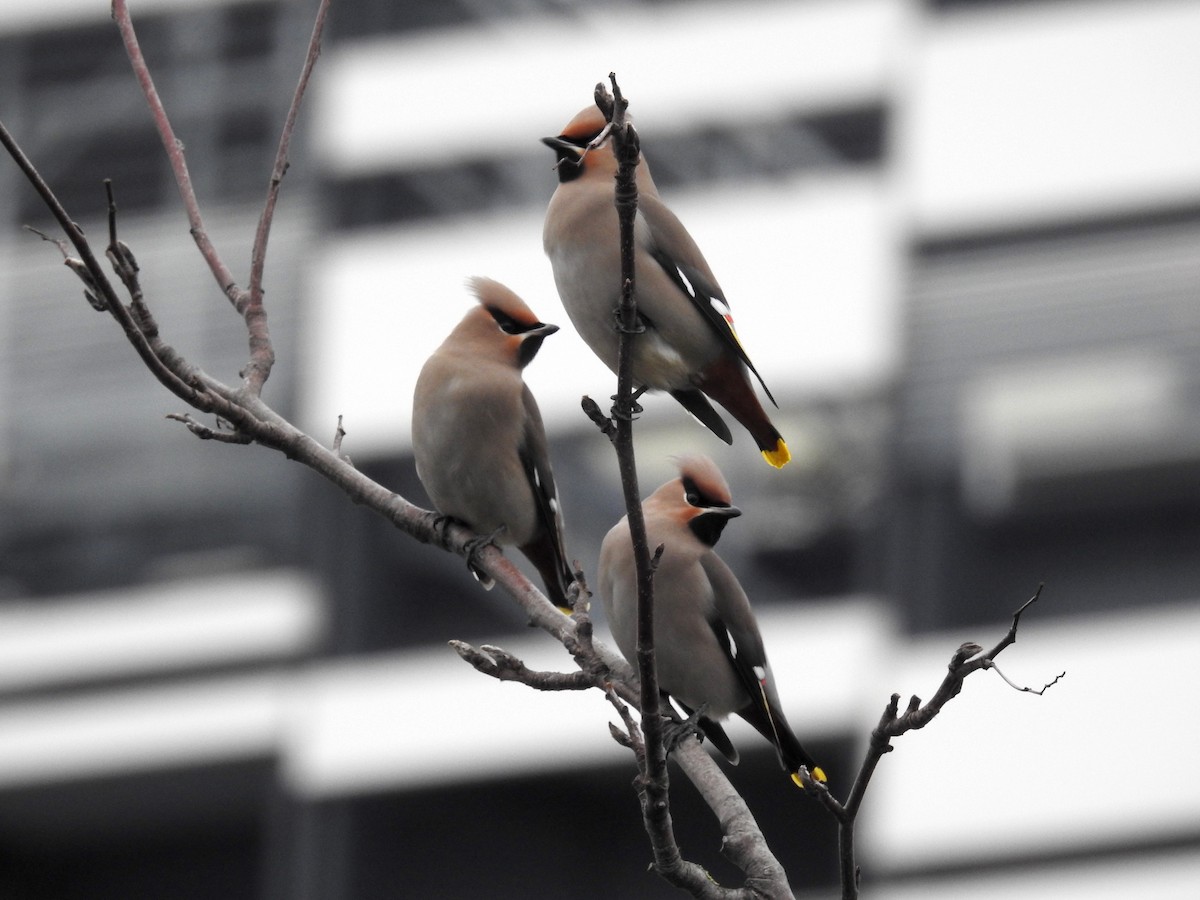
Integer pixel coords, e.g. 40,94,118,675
542,106,791,468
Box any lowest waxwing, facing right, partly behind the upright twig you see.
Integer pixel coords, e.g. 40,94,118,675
598,456,826,784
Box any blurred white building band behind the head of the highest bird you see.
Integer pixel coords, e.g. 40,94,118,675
316,0,905,173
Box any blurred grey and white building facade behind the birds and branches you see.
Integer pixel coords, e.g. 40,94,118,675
0,0,1200,900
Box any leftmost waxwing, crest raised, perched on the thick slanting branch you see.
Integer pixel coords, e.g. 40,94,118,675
413,278,574,611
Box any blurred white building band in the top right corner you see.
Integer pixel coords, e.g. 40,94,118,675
895,0,1200,233
